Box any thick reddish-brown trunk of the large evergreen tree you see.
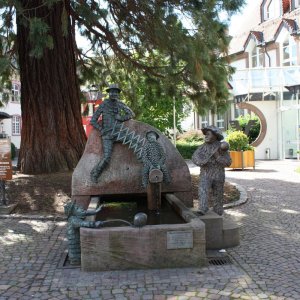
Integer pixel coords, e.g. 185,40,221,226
17,0,86,174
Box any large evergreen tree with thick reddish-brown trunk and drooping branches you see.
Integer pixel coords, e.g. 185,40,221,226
0,0,243,173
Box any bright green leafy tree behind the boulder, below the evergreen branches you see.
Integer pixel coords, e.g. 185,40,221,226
80,57,190,135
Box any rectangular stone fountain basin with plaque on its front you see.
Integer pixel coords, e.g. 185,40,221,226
80,194,206,271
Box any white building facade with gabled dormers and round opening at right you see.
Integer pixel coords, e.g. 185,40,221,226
194,0,300,159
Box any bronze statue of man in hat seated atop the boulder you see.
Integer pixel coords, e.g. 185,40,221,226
90,84,134,183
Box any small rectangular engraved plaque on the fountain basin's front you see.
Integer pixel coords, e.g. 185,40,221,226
167,230,193,249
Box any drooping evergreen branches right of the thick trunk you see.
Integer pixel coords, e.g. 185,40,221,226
72,0,244,112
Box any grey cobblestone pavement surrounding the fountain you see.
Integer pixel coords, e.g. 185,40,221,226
0,161,300,300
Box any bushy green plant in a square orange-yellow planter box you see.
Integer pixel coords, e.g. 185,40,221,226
225,130,255,169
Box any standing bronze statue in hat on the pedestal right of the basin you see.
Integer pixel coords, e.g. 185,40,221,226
192,126,231,216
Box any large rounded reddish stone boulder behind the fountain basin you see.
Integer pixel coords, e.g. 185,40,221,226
72,120,192,208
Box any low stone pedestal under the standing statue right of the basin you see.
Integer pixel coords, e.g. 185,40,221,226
199,210,240,250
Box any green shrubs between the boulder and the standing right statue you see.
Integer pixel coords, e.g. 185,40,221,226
176,130,204,159
